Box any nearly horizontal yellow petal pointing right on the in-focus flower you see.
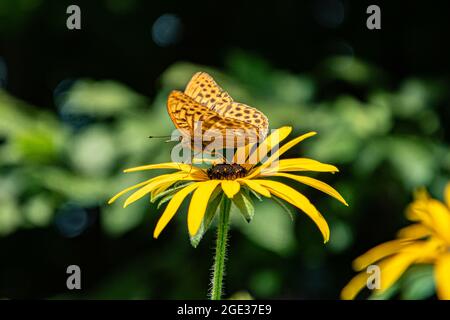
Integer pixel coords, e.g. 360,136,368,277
261,158,339,175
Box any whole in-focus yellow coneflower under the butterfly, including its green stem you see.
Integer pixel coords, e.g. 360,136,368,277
109,127,347,300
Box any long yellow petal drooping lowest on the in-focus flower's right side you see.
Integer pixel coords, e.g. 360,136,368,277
253,180,330,242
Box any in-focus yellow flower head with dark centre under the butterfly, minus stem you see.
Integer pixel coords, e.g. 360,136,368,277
108,127,347,242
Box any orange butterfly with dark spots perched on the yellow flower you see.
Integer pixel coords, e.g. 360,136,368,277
167,72,269,152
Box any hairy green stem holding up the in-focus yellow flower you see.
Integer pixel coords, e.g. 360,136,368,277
211,196,231,300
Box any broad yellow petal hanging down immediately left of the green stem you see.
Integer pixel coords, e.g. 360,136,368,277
188,180,220,236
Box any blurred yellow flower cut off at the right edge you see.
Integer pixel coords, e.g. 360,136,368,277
341,183,450,300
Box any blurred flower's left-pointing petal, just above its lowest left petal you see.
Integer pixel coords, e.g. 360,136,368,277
353,239,411,271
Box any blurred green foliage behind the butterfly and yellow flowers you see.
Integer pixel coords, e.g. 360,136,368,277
0,2,450,299
